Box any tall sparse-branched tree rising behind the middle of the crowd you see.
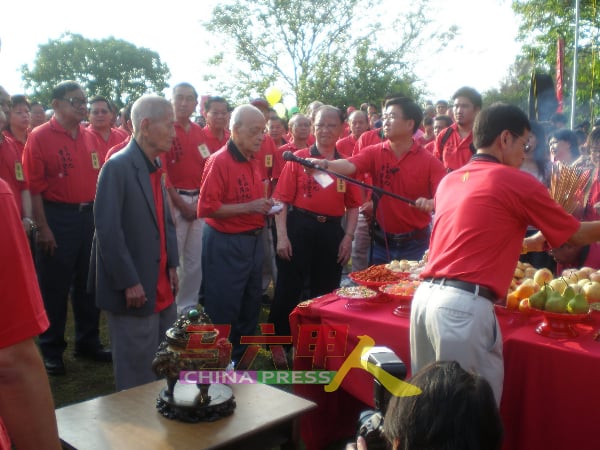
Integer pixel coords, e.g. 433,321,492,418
204,0,455,110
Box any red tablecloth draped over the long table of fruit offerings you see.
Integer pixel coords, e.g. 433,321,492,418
290,294,600,450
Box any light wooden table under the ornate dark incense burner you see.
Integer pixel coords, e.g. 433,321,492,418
56,380,316,450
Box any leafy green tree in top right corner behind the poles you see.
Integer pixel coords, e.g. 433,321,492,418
513,0,600,119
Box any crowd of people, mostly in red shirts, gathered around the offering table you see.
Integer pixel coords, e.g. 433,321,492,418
0,81,600,449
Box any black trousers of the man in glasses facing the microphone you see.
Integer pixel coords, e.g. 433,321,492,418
269,210,344,336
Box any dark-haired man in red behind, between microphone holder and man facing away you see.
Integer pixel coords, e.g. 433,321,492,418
433,87,482,172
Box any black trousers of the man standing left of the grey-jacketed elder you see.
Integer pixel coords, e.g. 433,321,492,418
37,203,100,358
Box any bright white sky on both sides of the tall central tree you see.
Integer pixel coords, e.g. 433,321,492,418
0,0,519,107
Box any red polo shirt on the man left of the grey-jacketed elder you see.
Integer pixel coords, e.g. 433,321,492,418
23,117,99,203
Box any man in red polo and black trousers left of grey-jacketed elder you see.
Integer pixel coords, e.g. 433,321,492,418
23,81,111,375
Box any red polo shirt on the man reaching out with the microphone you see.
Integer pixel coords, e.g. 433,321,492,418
348,141,446,234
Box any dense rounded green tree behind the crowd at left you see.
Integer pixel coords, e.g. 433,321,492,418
21,33,170,108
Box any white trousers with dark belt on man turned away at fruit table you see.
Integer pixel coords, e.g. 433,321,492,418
410,281,504,405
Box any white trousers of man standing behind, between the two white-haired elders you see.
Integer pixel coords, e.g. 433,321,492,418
174,195,204,315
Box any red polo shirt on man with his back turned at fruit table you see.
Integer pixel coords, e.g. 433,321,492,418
421,160,580,298
